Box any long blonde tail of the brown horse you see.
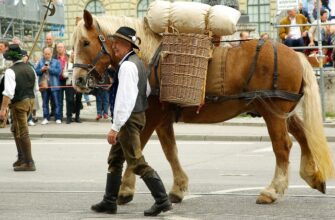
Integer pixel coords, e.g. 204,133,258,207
297,52,335,181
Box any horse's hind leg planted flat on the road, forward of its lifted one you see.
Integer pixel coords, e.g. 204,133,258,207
256,114,292,204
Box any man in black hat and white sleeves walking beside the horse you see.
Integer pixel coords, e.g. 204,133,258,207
91,27,172,216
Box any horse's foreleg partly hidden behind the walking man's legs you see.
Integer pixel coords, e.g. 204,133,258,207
117,98,163,205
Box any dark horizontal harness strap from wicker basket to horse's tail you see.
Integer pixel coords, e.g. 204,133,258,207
206,90,303,102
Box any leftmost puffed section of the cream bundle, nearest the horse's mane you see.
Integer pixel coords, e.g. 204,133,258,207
146,1,171,33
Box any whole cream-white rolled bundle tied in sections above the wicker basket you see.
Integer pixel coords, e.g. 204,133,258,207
146,0,241,36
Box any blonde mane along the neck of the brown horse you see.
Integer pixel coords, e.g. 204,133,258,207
85,15,161,64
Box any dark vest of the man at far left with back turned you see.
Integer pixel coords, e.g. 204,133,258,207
10,62,36,103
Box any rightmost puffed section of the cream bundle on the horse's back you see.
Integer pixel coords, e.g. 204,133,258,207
208,5,241,36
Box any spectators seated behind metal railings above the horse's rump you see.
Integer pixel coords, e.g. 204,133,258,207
279,0,335,66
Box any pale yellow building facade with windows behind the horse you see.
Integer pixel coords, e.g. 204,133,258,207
64,0,284,44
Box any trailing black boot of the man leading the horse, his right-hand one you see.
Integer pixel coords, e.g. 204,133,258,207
142,171,172,216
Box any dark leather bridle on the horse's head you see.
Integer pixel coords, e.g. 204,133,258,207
73,22,113,88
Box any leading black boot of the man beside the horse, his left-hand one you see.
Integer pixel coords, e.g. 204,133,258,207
91,173,121,214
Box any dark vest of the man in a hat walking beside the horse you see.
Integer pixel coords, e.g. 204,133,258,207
128,53,148,112
